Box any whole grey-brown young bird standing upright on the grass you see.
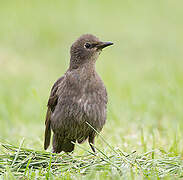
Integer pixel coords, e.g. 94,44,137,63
44,34,113,153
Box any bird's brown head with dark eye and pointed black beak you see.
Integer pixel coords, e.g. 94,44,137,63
70,34,113,67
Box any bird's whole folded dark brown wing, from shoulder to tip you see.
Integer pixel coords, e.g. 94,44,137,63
44,76,64,150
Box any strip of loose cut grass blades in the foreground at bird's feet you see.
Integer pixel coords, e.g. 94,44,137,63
0,138,183,179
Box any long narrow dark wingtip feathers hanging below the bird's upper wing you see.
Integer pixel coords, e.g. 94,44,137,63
44,108,51,150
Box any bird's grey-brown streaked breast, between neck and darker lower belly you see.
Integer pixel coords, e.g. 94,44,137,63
54,71,107,129
